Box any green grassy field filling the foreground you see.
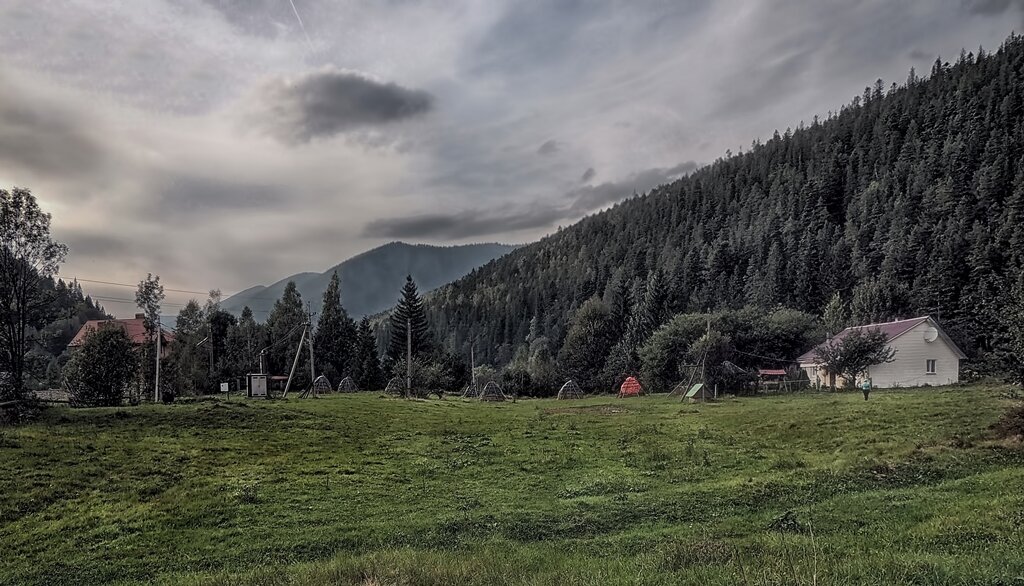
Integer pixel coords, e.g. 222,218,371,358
0,387,1024,586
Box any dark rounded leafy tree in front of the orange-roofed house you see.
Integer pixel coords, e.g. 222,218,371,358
65,325,138,407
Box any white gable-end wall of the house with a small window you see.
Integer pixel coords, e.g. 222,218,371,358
867,322,959,388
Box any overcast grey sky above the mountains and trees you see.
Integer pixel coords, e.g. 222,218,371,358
0,0,1024,316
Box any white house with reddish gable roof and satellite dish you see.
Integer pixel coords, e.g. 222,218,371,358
797,316,967,388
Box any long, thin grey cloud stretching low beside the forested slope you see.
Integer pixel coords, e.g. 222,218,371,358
362,161,697,240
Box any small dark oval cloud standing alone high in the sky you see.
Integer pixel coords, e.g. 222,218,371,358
256,69,434,142
